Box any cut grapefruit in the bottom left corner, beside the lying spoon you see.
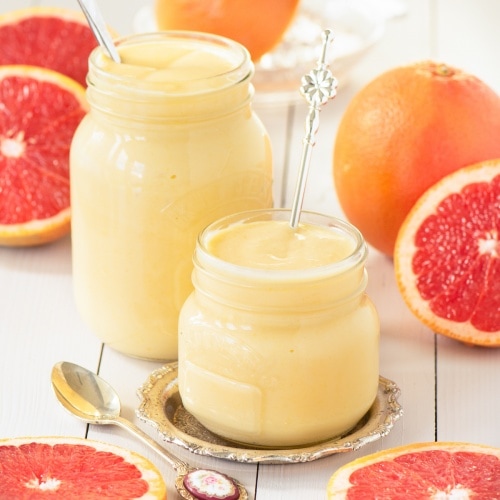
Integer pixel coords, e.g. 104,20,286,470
0,437,166,500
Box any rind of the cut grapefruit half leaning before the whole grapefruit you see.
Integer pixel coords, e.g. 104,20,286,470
394,159,500,347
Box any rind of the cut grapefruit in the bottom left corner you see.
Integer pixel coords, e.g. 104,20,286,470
0,436,167,500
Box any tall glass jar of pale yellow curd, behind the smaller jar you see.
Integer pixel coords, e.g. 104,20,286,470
70,32,272,360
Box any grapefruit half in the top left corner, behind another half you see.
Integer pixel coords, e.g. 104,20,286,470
0,7,97,86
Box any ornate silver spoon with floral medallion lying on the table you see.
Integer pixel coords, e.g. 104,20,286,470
51,361,248,500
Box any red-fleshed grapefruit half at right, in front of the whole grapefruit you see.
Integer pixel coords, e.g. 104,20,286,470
394,159,500,347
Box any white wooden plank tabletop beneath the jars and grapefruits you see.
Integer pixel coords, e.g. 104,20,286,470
0,0,500,500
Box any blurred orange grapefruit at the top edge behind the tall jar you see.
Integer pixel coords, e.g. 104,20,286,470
155,0,299,61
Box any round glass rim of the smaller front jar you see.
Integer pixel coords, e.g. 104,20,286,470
194,208,368,283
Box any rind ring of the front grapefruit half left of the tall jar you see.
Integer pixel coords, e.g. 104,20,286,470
0,65,89,246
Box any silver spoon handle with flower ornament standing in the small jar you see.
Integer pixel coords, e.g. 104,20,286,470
290,30,337,229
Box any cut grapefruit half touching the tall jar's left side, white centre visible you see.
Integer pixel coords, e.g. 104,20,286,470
0,65,88,246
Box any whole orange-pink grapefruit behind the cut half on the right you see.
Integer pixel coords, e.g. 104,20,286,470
333,62,500,255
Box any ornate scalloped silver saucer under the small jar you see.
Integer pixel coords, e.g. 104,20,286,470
135,362,403,464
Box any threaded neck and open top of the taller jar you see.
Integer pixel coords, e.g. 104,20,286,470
87,31,254,122
